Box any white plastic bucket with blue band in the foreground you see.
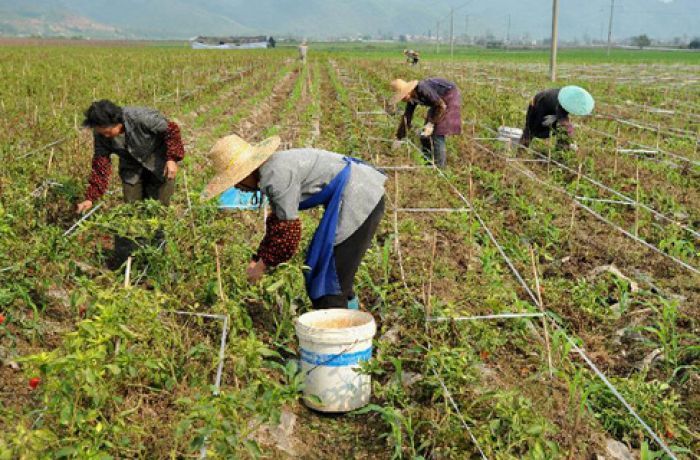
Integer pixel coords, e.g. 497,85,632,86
295,308,377,412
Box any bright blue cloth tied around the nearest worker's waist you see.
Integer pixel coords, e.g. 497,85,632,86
299,157,362,300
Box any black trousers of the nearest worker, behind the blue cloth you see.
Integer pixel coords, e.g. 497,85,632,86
312,197,384,308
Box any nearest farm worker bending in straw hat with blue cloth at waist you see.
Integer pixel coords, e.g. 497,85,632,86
204,135,386,309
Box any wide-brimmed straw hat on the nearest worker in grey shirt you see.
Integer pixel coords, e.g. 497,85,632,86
204,134,280,198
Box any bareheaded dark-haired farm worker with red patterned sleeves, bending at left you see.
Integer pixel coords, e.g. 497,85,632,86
77,99,185,266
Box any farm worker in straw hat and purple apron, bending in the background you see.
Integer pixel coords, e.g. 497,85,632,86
391,78,462,168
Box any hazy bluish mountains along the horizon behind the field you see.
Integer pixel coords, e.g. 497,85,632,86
0,0,700,40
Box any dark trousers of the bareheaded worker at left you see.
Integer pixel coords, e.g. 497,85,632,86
110,170,175,268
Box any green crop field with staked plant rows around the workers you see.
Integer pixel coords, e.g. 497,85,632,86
0,42,700,459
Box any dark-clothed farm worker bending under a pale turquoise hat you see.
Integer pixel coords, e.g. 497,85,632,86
520,86,595,150
